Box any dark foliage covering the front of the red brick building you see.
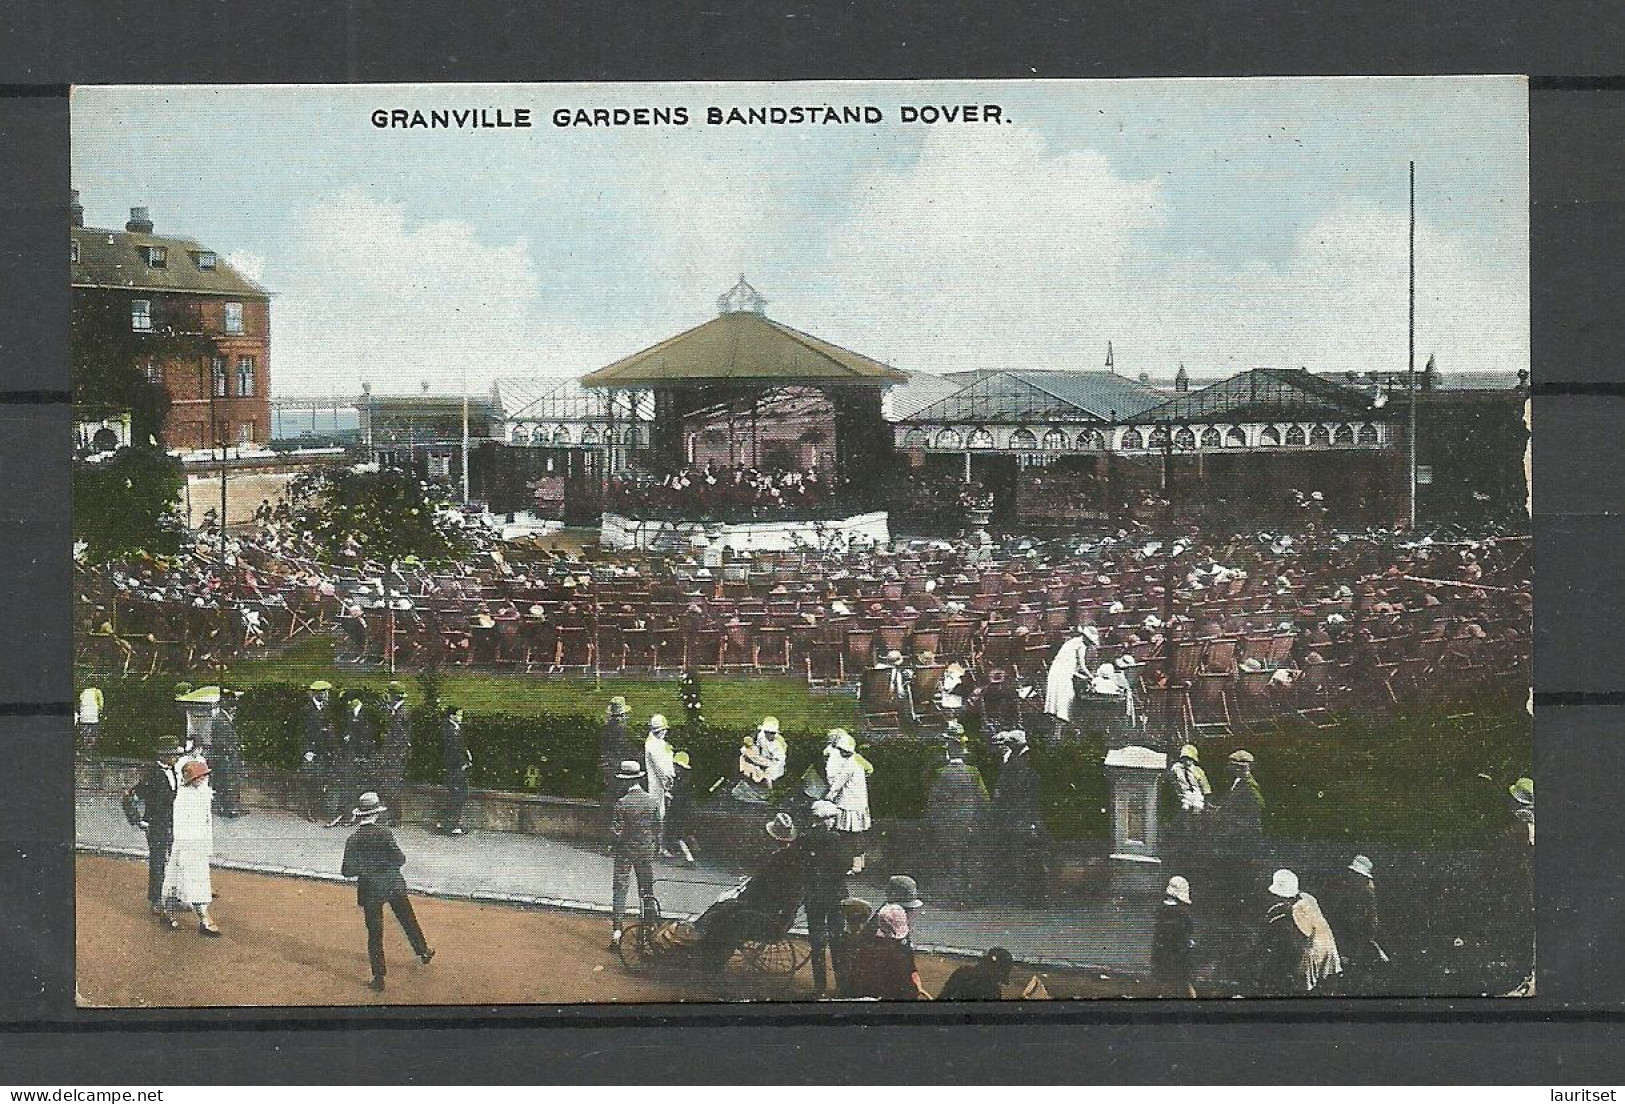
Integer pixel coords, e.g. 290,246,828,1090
70,289,219,447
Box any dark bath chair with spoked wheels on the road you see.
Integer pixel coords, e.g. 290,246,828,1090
618,844,811,977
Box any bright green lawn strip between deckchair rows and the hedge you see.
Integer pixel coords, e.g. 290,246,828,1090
216,637,858,732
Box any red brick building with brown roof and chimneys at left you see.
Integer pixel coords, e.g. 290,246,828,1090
68,192,271,452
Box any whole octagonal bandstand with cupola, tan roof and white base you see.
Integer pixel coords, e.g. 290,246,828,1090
580,276,908,550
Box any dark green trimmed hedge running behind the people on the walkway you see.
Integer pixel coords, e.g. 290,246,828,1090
82,676,1534,847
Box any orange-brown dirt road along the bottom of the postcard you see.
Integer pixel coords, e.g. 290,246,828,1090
75,855,1133,1008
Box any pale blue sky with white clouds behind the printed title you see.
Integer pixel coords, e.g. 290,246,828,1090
72,76,1529,397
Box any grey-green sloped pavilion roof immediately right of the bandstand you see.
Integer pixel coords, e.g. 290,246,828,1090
899,371,1164,424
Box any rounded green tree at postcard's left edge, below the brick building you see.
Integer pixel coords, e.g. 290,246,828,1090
73,447,185,564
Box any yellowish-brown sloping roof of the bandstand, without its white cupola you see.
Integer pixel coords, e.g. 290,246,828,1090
582,311,908,387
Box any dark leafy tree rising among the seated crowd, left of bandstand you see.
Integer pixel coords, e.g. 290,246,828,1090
288,467,466,563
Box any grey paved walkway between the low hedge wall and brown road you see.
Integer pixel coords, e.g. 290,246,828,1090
76,793,1160,974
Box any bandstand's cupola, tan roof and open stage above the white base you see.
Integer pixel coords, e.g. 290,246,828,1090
582,276,908,494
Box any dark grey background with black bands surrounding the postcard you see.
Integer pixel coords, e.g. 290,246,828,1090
0,0,1625,1086
